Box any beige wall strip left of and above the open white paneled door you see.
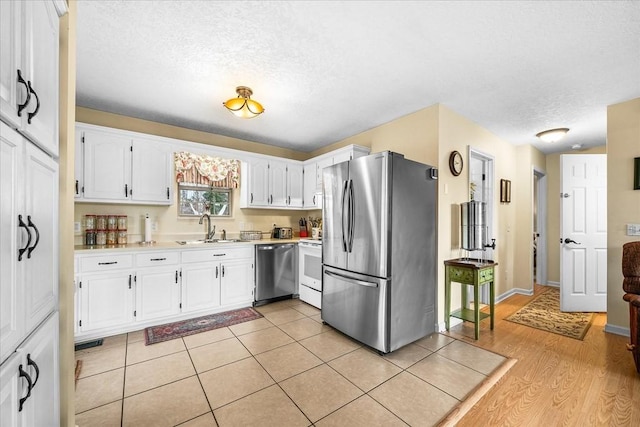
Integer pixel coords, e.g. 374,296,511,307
547,145,607,285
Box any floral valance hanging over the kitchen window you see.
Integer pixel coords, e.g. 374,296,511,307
175,151,240,188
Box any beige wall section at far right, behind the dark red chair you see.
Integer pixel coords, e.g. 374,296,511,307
607,98,640,332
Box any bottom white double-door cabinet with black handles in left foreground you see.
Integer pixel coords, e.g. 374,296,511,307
0,312,60,427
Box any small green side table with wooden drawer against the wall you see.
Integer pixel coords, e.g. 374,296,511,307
444,258,498,339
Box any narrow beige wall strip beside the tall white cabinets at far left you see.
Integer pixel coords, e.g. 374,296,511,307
58,1,77,426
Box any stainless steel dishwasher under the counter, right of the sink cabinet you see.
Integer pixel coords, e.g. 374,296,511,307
253,243,298,306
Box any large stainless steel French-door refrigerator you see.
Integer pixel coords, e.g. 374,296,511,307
322,151,437,353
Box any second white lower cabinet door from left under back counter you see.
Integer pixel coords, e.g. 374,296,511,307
135,267,180,321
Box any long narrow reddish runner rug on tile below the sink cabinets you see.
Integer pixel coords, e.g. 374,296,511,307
144,307,262,345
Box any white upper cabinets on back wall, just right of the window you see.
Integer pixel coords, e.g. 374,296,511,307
241,158,304,209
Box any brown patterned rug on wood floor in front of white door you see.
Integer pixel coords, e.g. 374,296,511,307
505,288,593,340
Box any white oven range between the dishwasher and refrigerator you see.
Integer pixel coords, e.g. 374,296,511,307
298,239,322,308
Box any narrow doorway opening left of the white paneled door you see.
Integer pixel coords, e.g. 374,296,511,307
531,168,547,289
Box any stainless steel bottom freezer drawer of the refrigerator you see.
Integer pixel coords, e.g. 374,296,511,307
322,266,390,353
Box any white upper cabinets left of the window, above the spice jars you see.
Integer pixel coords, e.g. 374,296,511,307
75,125,173,205
